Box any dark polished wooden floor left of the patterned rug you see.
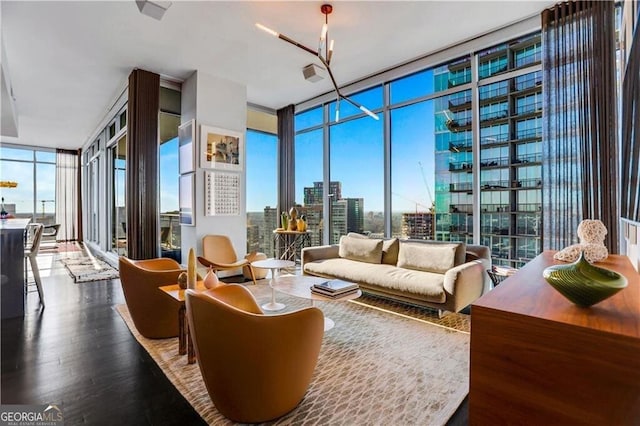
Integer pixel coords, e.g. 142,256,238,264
0,248,468,425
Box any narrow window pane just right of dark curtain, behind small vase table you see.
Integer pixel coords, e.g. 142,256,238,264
295,129,324,246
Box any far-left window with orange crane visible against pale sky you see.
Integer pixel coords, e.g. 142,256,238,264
0,145,56,224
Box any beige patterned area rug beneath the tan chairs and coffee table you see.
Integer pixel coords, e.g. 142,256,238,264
116,284,469,426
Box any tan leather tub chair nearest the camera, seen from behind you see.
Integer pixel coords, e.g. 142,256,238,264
186,284,324,423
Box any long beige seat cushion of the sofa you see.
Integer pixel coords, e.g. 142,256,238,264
304,258,446,303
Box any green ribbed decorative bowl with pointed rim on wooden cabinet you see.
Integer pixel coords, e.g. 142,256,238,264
542,252,627,308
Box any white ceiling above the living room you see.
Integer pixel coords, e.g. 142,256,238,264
0,0,554,148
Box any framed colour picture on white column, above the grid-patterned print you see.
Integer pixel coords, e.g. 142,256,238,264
200,125,244,171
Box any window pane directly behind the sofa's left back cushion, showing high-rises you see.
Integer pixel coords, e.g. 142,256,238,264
328,116,384,244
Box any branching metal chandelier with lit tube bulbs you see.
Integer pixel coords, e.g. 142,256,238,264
256,4,379,122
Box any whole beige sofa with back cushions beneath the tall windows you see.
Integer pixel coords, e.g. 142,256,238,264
302,233,491,312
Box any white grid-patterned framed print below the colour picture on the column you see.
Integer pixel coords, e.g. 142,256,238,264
204,172,240,216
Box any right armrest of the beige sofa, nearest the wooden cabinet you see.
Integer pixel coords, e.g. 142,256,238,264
444,260,485,312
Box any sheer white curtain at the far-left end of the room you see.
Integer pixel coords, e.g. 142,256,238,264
56,149,80,241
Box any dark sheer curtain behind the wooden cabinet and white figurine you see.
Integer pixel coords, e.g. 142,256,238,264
542,1,620,253
